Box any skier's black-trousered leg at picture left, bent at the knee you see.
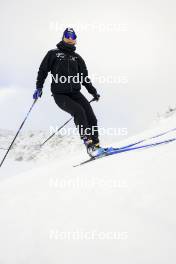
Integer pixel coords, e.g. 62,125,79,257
53,94,88,139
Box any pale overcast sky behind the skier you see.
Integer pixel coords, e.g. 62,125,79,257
0,0,176,139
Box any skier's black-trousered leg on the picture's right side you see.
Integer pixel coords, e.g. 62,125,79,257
72,93,99,144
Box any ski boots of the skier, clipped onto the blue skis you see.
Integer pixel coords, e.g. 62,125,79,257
83,138,105,158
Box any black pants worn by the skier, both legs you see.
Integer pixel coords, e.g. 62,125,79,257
53,92,99,144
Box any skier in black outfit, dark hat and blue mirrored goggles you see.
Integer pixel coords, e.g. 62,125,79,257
33,28,103,156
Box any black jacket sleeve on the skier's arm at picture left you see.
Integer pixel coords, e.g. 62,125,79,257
36,51,52,89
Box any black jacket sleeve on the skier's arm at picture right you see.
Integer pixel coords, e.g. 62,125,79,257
78,55,97,94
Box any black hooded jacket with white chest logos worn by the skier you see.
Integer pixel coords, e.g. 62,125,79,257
36,41,97,94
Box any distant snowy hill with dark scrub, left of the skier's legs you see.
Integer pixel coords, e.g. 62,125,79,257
0,130,83,177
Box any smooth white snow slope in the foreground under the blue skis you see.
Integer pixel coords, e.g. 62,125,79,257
0,114,176,264
